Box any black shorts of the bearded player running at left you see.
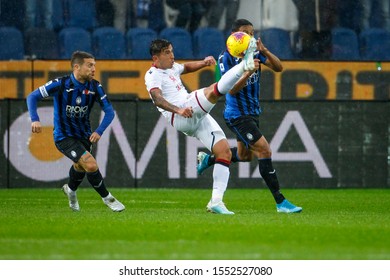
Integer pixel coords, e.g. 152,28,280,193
55,138,92,163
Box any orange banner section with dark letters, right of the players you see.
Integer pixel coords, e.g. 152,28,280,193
274,61,390,100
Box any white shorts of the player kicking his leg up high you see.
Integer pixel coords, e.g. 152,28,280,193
170,89,226,151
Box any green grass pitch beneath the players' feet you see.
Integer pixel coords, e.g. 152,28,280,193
0,187,390,260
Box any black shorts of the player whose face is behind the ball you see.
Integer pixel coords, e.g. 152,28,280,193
225,116,263,148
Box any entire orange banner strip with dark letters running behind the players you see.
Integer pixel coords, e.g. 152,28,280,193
0,60,390,100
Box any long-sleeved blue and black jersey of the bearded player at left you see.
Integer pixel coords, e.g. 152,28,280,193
27,74,115,141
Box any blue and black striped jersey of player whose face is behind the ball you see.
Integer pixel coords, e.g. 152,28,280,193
218,51,267,120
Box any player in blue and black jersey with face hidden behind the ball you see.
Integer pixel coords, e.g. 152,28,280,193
197,19,302,213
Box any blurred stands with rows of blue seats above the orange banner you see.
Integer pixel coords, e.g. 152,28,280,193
0,0,390,61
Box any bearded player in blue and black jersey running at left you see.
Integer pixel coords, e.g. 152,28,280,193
27,51,125,212
